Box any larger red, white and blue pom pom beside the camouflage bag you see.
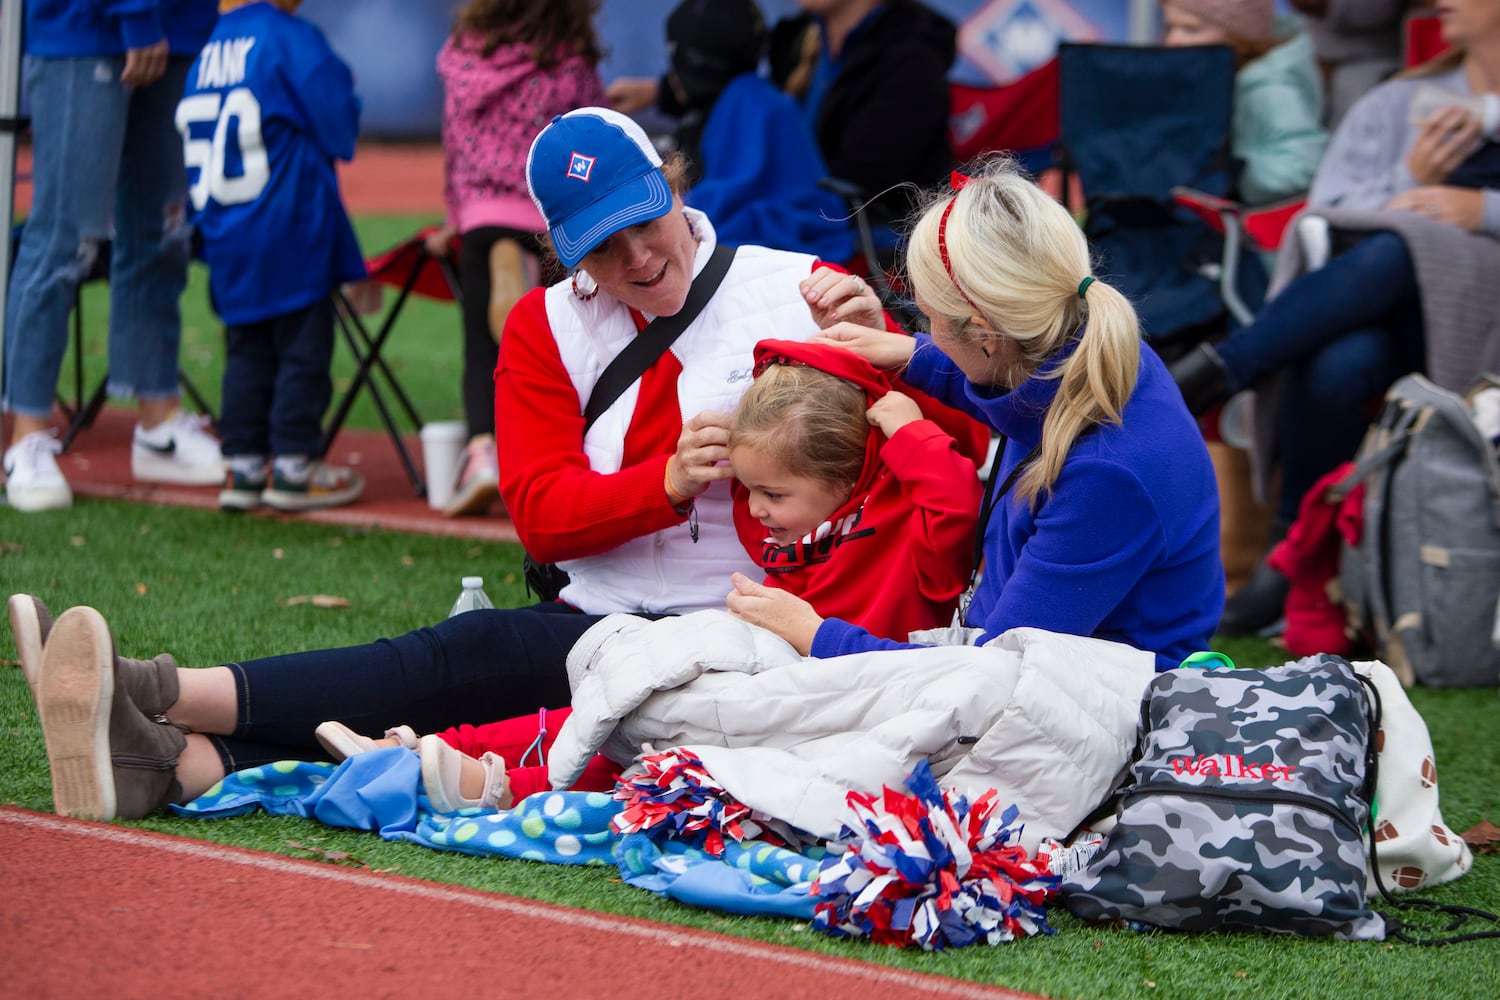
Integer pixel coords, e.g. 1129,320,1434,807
813,760,1059,951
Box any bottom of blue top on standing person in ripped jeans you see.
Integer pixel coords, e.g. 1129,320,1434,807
26,0,219,58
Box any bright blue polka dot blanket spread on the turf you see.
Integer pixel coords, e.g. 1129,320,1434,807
173,748,822,919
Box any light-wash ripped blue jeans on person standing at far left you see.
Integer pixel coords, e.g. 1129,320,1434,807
0,55,192,418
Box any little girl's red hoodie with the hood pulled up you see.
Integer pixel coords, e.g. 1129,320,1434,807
734,340,980,640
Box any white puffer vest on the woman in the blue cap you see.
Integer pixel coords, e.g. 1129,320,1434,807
546,215,818,615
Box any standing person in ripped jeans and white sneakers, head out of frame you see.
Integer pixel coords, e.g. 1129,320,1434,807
0,0,224,511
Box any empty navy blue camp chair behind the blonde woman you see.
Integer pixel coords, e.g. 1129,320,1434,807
1058,43,1266,360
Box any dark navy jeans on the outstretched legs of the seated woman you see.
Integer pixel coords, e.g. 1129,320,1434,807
209,603,600,772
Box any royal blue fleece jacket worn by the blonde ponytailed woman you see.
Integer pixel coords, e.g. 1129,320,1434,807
812,334,1224,670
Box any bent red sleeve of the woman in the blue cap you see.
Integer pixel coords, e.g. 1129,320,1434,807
495,288,683,562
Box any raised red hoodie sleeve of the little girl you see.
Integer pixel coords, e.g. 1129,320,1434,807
881,420,981,603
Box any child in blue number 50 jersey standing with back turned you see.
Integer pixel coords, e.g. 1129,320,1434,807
177,0,366,510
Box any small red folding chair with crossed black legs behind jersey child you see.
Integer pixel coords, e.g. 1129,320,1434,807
320,226,464,496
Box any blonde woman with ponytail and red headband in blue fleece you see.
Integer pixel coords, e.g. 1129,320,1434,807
729,159,1224,670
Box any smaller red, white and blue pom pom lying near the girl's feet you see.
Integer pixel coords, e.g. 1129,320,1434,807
611,748,792,858
